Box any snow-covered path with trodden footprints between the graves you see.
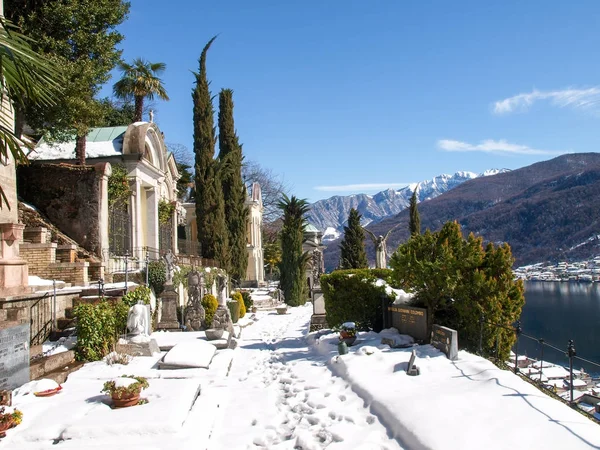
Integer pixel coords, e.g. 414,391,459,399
208,305,401,450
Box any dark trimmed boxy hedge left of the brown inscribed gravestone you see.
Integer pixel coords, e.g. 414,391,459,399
321,269,394,331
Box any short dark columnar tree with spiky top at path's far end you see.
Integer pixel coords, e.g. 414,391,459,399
278,194,309,306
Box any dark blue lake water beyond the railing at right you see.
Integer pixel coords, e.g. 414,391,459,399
519,281,600,374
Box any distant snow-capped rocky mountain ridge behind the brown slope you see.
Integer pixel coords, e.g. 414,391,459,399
306,169,508,242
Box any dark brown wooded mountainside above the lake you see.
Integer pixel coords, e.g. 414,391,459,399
325,153,600,270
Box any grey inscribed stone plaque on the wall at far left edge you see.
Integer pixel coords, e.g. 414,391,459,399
0,323,29,390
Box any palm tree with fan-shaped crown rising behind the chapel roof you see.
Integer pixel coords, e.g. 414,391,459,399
113,58,169,122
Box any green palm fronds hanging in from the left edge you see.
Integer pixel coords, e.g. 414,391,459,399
0,16,61,209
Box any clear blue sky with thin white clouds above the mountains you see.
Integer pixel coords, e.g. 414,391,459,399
103,0,600,201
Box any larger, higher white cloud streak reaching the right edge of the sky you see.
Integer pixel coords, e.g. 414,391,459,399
494,87,600,114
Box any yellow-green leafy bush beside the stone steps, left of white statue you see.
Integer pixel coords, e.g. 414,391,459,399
73,300,129,361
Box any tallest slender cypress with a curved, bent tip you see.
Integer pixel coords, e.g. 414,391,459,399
192,36,229,270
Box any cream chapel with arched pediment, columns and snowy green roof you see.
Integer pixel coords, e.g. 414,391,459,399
19,122,185,272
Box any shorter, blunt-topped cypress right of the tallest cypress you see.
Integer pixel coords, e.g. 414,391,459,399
219,89,248,281
